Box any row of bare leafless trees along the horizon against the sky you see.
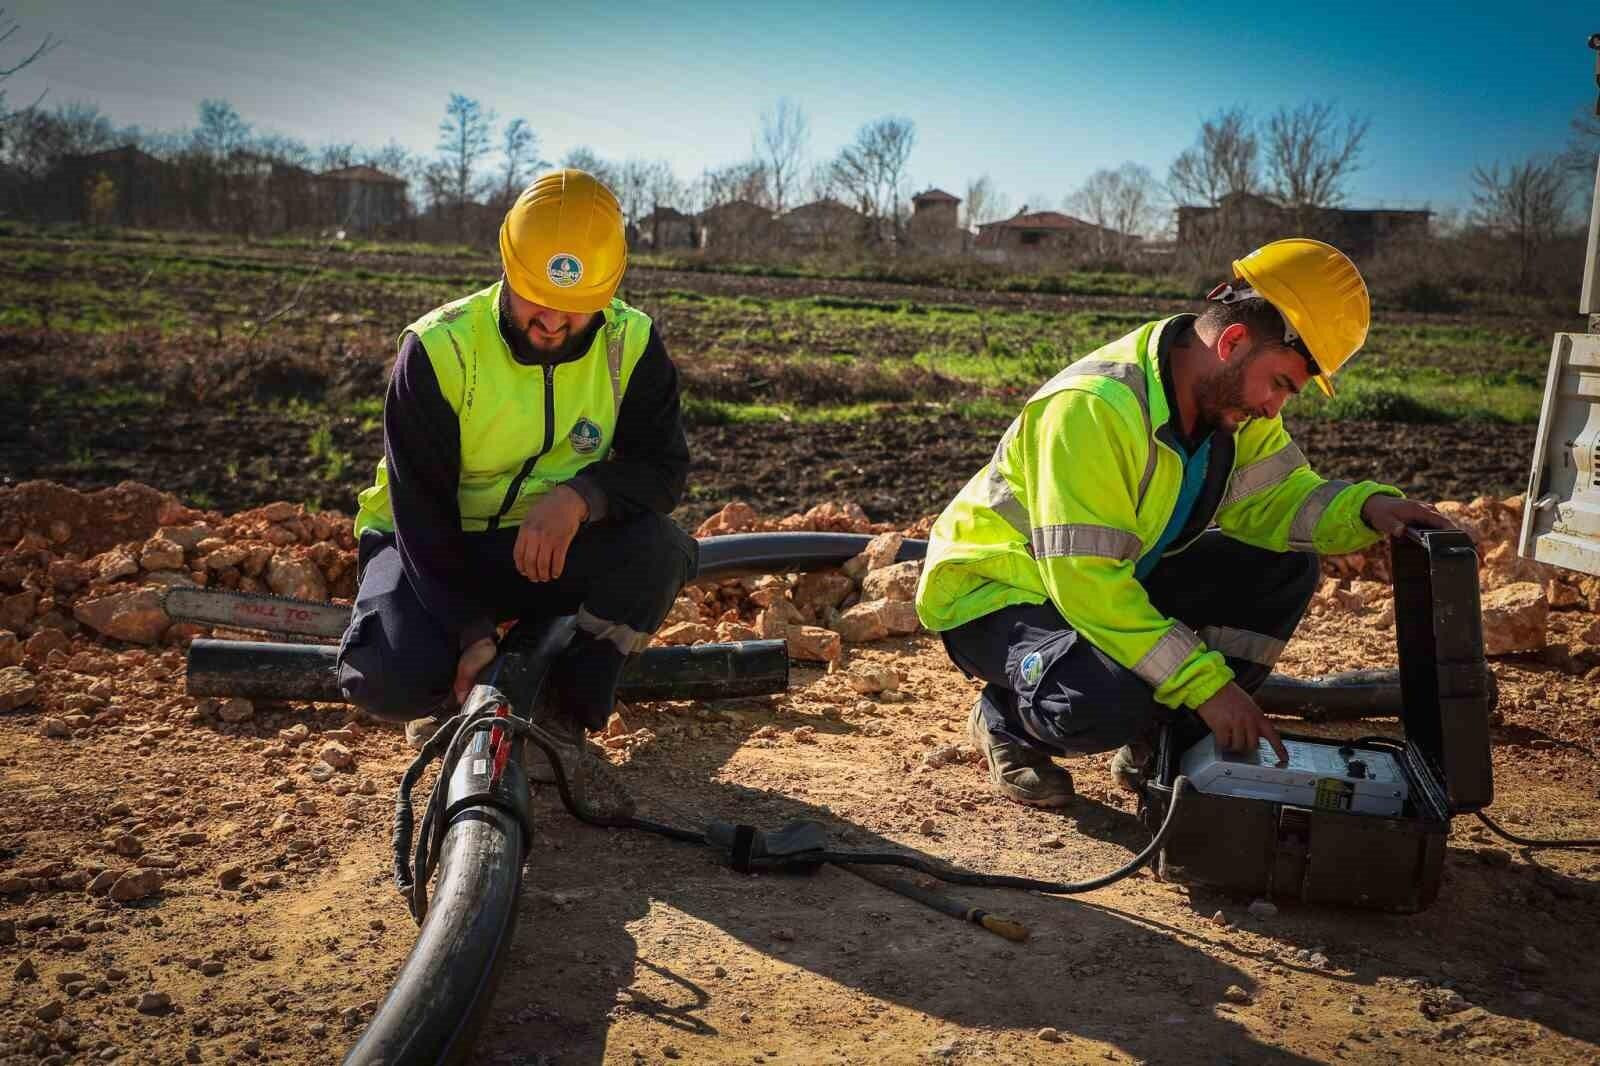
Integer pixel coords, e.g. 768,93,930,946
0,10,1600,291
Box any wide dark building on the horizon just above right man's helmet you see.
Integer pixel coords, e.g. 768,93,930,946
1178,192,1434,256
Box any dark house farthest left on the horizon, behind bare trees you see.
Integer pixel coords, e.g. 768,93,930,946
43,144,181,226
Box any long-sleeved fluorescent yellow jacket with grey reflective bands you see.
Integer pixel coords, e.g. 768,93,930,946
917,317,1400,707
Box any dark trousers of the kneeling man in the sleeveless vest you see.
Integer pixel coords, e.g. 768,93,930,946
339,512,698,730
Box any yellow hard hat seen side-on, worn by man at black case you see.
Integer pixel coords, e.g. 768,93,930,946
1234,237,1373,397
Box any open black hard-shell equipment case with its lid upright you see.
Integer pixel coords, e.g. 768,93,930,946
1144,530,1494,912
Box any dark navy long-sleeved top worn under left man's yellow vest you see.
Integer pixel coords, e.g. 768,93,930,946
384,299,690,647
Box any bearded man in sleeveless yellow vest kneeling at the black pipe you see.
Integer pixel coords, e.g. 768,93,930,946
338,161,696,784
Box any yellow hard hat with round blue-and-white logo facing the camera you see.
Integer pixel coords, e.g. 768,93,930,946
501,168,627,312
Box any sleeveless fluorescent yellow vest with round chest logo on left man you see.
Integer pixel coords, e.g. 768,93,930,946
355,282,650,535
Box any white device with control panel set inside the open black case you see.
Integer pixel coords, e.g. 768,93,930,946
1179,736,1411,816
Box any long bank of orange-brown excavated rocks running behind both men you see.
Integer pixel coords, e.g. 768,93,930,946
0,482,1600,711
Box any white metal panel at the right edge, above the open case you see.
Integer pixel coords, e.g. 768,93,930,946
1517,333,1600,575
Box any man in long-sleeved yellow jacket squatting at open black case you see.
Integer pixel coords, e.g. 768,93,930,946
917,238,1450,807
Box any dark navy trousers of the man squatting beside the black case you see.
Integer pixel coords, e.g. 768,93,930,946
944,530,1318,755
